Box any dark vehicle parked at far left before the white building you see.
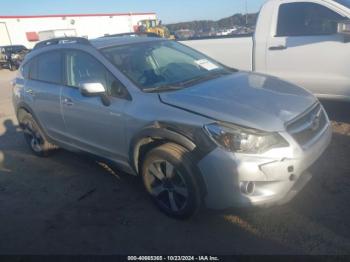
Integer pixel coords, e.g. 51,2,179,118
0,45,29,71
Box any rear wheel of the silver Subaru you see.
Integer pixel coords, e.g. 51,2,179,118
20,113,57,157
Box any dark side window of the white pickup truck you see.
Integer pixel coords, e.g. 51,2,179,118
276,2,346,36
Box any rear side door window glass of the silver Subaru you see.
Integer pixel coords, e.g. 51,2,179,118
30,52,62,84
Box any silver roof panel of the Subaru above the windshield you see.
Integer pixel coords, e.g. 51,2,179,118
90,36,166,49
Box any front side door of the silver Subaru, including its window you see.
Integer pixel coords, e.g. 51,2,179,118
62,50,130,164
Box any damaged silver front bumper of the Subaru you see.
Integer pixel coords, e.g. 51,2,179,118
198,123,332,209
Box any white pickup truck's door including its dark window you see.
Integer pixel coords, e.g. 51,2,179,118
262,0,350,98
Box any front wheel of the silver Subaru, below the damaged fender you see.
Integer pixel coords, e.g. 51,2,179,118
141,143,202,219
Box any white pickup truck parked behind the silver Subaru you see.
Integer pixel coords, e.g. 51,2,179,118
183,0,350,101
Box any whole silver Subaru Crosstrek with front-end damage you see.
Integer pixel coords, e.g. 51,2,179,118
13,36,332,218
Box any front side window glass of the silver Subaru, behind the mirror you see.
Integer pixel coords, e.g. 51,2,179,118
65,50,127,98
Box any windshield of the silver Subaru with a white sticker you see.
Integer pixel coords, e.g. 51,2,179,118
103,41,232,91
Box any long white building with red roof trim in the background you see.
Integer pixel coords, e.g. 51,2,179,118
0,13,157,48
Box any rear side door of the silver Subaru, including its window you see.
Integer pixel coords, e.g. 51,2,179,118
25,51,66,142
